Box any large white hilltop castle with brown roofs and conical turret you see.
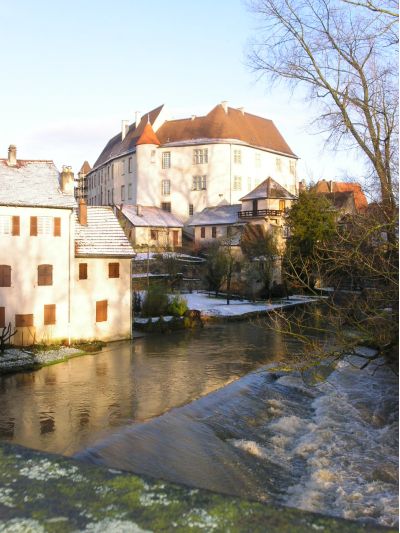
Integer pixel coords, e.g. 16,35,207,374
86,102,298,221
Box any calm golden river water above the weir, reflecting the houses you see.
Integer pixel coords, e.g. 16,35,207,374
0,322,285,455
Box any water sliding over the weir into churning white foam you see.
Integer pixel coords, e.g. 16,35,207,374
80,356,398,525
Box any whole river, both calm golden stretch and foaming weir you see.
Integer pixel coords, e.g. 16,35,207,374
0,322,398,525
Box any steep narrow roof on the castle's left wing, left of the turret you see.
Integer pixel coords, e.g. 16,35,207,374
93,105,164,168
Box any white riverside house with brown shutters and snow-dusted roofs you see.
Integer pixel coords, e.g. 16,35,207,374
0,146,134,344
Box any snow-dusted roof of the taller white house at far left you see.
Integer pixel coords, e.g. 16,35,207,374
0,159,76,208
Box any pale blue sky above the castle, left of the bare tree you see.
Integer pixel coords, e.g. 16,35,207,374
0,0,362,181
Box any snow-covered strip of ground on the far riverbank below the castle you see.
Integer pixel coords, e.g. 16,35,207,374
183,292,319,316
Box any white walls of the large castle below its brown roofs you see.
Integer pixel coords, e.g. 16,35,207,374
88,104,298,222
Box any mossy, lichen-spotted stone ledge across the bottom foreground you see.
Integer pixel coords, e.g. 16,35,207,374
0,443,395,533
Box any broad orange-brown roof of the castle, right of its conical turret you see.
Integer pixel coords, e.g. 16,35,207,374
157,104,296,157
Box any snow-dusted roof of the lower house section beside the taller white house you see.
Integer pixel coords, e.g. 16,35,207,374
75,205,135,257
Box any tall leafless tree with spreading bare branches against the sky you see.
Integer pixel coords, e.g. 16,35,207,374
250,0,398,216
